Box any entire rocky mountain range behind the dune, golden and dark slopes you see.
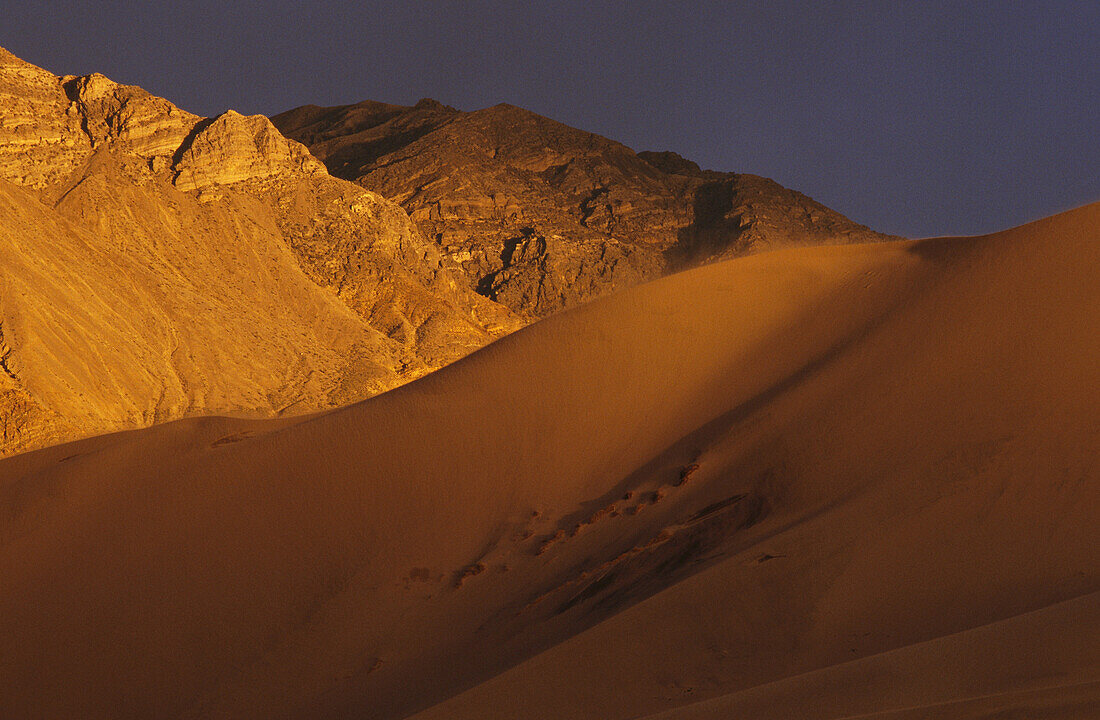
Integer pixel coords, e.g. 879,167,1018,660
0,49,882,454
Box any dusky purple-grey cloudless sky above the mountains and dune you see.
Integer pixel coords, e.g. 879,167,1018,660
0,0,1100,236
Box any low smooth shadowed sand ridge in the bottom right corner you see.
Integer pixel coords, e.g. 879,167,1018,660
655,592,1100,720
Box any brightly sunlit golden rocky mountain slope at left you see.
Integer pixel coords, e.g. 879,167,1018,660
0,49,519,453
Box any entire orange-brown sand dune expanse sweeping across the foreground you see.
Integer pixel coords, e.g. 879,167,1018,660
0,204,1100,720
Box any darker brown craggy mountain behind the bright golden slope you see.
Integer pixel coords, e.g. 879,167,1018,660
272,100,897,319
